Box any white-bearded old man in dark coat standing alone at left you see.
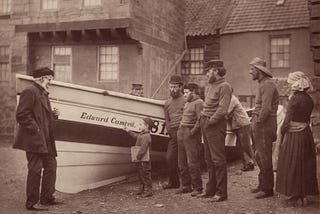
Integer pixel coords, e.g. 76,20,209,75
13,68,62,211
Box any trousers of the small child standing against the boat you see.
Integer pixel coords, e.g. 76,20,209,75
136,161,152,190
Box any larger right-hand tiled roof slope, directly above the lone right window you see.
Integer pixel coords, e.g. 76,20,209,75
222,0,309,33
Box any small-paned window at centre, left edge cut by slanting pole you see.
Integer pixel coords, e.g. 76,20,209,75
181,48,204,75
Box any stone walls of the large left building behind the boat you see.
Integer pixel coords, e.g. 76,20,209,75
0,0,185,137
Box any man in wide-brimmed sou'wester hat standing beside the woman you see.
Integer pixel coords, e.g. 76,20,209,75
249,57,279,199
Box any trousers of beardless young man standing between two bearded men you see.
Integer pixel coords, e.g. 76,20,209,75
177,127,203,191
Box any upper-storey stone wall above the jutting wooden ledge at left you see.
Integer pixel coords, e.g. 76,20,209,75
12,0,130,24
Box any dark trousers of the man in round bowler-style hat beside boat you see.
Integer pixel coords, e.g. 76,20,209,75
166,128,180,186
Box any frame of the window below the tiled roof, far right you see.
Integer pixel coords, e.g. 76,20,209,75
269,34,291,69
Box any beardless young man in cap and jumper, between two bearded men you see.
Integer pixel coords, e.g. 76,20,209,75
177,83,203,196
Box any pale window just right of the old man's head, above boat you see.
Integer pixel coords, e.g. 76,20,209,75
52,46,72,82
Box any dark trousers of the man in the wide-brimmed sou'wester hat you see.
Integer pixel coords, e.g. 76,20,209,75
252,116,277,192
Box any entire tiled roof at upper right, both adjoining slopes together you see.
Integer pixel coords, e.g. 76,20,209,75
185,0,309,36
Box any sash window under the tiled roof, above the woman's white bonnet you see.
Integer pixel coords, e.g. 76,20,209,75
270,36,290,68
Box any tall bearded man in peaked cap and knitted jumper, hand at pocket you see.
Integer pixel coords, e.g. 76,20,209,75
200,60,232,202
